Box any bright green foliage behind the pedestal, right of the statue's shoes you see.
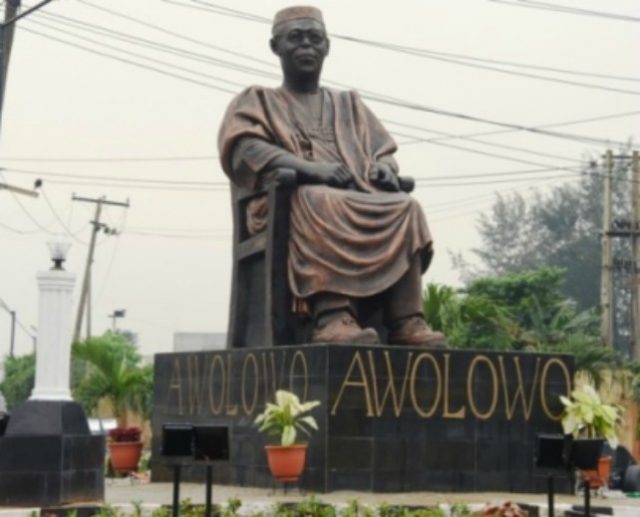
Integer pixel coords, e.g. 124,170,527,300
424,267,598,350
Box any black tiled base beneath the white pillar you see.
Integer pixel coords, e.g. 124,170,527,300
0,400,105,507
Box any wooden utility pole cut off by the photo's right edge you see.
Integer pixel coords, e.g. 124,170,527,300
631,151,640,359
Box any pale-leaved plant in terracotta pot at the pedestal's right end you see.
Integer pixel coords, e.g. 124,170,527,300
560,384,621,488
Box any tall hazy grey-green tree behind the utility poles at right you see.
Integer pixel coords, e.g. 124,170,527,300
454,155,629,309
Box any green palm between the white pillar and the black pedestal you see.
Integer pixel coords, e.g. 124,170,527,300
72,332,153,427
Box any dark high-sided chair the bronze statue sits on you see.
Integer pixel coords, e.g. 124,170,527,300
227,169,414,348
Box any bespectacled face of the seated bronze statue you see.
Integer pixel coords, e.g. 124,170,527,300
271,18,329,76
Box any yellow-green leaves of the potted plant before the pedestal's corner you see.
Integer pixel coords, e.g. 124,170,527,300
255,390,320,447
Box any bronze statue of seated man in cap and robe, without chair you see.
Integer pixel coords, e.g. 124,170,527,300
218,7,444,346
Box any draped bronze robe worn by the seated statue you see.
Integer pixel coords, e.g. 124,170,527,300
218,86,432,306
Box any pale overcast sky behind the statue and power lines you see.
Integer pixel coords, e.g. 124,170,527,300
0,0,640,355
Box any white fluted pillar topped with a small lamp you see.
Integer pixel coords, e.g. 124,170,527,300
30,246,76,400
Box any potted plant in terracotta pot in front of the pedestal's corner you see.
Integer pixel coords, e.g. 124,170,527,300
255,390,320,482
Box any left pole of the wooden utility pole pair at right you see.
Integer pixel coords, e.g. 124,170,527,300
600,150,613,348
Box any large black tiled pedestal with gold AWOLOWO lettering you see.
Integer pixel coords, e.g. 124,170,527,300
152,345,573,492
